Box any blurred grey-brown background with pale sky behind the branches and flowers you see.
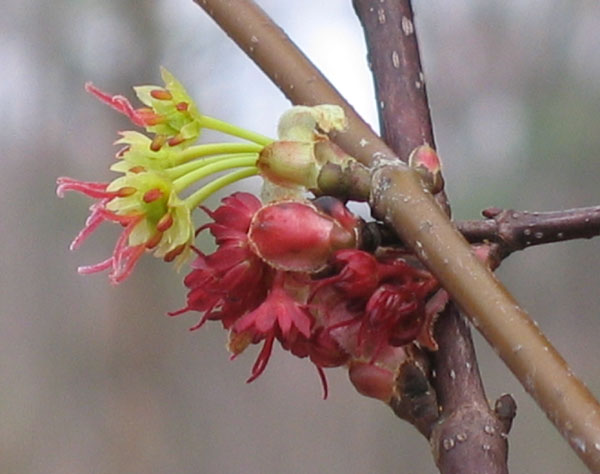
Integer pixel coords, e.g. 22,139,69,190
0,0,600,474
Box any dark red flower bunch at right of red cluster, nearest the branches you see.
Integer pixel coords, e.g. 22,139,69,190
311,249,438,360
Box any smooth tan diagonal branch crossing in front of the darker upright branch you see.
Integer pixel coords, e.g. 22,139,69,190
197,0,600,472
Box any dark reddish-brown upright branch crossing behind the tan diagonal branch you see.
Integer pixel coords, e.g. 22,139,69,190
353,0,508,474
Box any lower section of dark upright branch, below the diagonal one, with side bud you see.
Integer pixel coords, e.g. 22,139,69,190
430,305,515,474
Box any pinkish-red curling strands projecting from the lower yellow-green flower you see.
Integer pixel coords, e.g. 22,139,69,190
56,177,146,284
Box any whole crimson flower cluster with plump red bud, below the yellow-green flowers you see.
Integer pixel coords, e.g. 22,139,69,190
172,193,439,398
